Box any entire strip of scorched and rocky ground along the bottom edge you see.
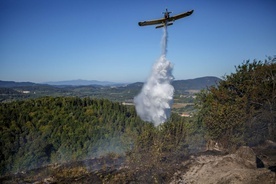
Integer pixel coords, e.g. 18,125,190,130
0,141,276,184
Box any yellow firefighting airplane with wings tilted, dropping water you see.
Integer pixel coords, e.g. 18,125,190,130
138,9,194,28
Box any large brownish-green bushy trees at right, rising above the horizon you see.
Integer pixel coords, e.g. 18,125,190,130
197,57,276,149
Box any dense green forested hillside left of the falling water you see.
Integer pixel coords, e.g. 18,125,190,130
0,97,148,173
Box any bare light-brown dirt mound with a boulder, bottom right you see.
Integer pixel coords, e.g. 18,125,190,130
171,147,276,184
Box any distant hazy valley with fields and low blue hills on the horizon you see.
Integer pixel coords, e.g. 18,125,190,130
0,77,220,116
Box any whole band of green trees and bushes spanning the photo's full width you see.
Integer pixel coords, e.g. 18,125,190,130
0,57,276,175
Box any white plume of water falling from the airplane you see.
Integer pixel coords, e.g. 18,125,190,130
134,27,174,126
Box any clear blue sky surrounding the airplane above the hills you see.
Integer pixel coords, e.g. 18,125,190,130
0,0,276,82
